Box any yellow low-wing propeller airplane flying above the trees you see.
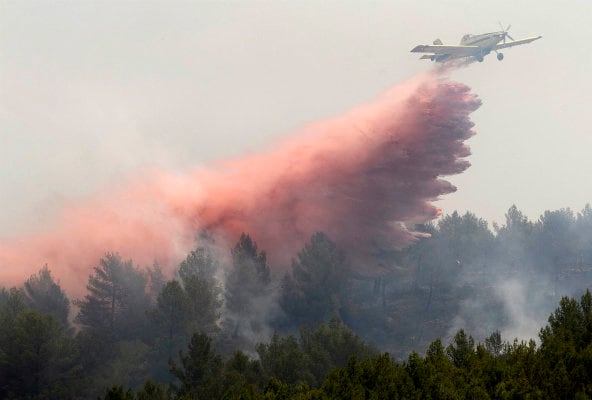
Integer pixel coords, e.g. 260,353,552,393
411,24,542,62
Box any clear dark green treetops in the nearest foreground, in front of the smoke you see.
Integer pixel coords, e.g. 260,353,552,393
91,291,592,400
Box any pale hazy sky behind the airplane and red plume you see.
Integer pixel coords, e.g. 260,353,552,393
0,0,592,238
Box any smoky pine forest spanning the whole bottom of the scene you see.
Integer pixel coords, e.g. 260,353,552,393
0,205,592,399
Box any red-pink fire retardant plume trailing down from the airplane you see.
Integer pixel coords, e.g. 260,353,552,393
0,74,480,294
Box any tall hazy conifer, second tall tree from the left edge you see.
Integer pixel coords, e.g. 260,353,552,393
74,253,151,395
